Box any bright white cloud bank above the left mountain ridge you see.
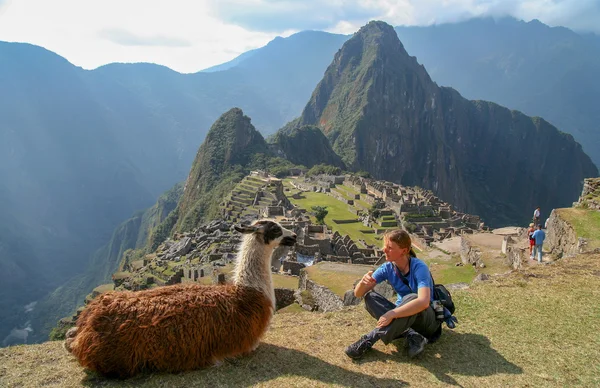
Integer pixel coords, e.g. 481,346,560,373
0,0,289,73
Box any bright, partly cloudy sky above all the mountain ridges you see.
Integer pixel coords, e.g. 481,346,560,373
0,0,600,73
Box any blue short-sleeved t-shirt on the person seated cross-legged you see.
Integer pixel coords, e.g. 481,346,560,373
373,257,433,306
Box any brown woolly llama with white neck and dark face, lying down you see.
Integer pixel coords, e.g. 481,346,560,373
65,220,296,378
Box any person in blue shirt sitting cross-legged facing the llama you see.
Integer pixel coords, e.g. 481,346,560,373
345,230,442,359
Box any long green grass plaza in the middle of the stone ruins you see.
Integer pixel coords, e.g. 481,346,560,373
290,192,381,245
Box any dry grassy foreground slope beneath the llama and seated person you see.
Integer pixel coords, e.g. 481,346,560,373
0,255,600,387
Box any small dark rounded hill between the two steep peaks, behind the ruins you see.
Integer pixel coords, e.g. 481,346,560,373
269,122,345,168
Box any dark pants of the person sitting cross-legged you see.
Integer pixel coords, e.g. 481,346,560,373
365,291,442,345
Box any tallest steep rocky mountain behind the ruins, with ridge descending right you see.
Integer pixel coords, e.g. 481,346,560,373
288,22,598,225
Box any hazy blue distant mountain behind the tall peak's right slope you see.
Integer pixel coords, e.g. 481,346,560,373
396,18,600,165
